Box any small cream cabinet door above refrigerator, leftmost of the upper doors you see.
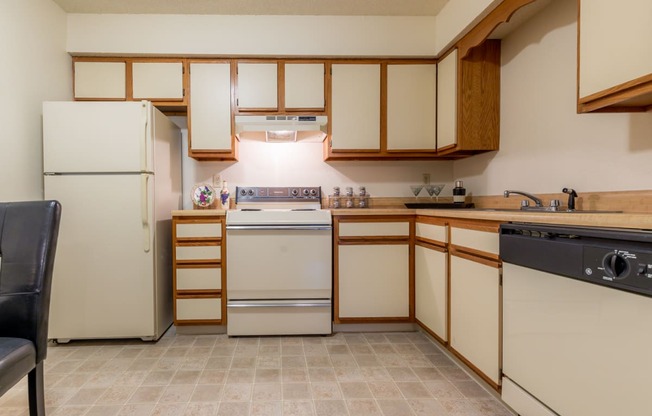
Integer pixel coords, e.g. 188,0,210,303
74,61,127,100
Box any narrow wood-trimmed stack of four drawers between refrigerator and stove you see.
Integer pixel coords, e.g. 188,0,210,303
172,215,226,325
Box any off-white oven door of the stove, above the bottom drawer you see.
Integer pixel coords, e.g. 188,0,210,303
226,225,332,300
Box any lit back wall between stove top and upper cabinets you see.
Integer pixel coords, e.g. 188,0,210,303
168,118,454,209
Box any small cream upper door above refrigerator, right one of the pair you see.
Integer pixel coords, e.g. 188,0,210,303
131,62,183,101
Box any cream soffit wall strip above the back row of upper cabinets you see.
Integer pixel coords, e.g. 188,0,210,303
68,14,435,56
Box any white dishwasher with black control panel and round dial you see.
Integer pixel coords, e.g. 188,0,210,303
500,224,652,416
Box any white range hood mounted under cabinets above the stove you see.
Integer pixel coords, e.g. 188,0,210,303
235,115,328,142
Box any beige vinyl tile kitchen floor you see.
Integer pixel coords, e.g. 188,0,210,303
0,327,513,416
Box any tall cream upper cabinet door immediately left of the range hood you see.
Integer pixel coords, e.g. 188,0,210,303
188,62,231,151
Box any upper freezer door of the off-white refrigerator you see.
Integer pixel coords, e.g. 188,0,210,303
43,101,153,173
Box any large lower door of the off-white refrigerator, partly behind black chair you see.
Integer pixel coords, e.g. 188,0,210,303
44,174,163,340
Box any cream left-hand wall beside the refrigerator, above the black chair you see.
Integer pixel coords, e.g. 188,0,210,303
0,0,72,201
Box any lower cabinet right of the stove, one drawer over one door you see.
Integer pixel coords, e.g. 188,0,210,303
333,216,414,323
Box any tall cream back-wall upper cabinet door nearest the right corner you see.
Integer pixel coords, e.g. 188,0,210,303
387,65,437,150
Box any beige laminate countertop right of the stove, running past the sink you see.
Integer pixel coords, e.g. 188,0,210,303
331,208,652,230
